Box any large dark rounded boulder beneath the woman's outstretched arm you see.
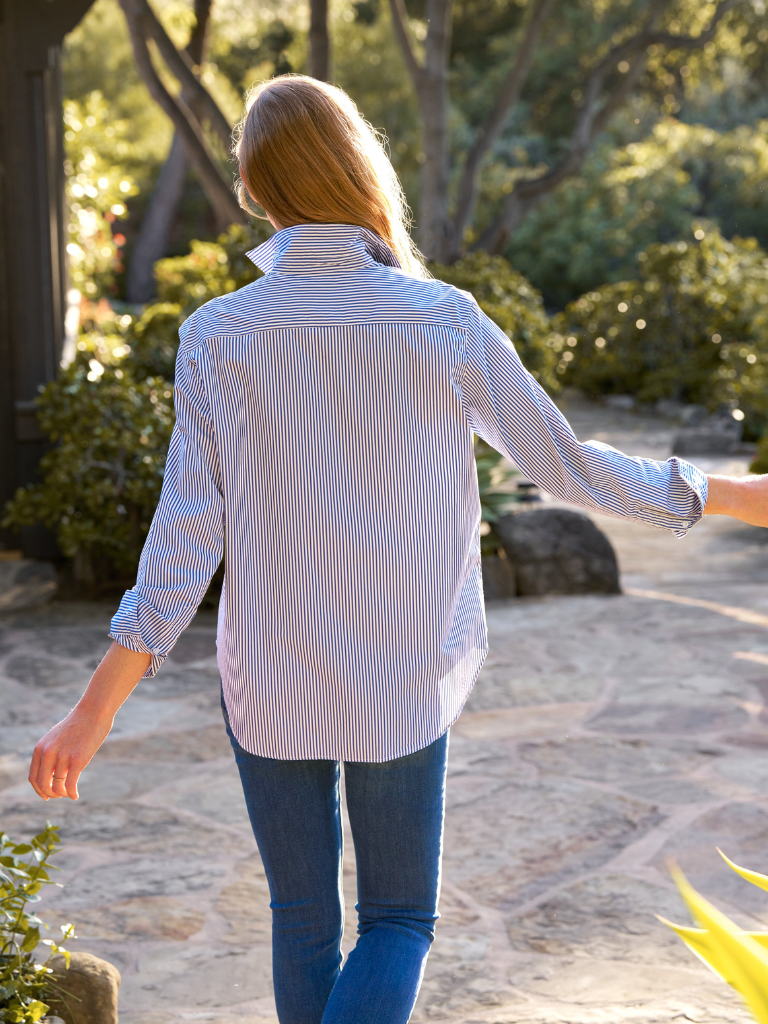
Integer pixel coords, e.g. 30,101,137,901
494,509,621,596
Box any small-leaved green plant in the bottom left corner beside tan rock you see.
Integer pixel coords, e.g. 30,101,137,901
0,822,76,1024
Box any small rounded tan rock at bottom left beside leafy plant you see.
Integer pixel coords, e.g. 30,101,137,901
45,953,120,1024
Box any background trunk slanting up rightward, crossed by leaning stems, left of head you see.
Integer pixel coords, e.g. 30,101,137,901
126,0,213,302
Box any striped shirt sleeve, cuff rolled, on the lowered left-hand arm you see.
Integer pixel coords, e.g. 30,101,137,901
110,350,224,678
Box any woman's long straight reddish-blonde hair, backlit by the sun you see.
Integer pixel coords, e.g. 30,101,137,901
234,75,429,278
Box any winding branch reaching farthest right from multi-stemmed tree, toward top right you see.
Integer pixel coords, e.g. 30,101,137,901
481,0,739,252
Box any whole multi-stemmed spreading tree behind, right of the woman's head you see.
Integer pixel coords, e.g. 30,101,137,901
390,0,738,262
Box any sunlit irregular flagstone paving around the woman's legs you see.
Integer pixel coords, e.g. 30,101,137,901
0,393,768,1024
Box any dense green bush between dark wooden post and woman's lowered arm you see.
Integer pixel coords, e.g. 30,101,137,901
3,224,267,587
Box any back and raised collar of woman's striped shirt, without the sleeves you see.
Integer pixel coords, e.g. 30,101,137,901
179,224,486,760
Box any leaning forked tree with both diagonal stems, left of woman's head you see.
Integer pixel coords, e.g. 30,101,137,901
119,0,246,230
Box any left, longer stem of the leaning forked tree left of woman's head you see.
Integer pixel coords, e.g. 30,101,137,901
120,0,245,228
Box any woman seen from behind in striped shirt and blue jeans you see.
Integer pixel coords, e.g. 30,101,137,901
30,76,768,1024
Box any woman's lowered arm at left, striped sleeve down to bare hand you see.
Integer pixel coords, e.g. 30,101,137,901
29,339,224,800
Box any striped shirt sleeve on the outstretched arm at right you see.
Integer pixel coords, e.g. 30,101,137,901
460,300,707,537
